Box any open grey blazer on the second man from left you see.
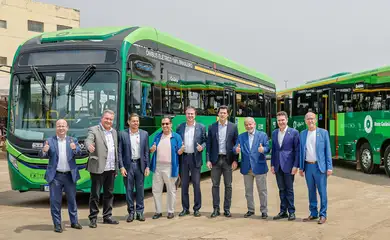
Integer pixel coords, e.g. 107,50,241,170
85,124,119,174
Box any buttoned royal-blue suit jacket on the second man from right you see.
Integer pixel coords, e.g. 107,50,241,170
271,127,300,173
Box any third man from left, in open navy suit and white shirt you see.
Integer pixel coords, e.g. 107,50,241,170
118,113,150,222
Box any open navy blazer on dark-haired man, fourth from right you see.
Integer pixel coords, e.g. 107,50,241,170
206,121,238,164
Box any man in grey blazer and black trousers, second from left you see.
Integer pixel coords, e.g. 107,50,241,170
85,110,119,228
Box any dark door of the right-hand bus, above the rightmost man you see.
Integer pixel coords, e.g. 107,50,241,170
318,90,333,131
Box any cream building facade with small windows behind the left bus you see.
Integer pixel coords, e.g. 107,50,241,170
0,0,80,95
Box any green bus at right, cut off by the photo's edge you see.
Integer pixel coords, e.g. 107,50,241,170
277,66,390,177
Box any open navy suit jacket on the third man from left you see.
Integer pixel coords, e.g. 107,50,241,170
118,129,150,172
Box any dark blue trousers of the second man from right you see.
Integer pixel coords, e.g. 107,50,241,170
275,167,295,214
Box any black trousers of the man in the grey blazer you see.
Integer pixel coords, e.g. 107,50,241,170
89,171,115,220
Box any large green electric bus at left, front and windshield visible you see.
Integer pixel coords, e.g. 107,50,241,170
7,27,276,194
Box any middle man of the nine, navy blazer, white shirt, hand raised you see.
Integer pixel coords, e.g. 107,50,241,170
176,106,206,217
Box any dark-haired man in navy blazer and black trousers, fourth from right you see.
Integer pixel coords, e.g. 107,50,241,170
206,105,238,217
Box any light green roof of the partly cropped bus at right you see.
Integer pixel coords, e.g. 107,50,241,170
277,66,390,96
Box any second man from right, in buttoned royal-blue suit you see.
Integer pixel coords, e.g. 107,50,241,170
271,111,299,221
